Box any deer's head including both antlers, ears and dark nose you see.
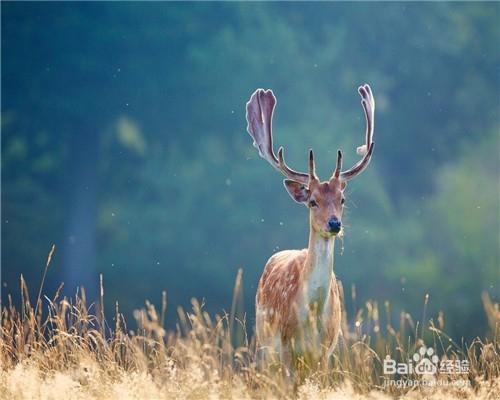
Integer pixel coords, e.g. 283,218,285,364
246,84,375,237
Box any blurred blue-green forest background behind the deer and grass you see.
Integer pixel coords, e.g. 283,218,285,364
1,3,500,337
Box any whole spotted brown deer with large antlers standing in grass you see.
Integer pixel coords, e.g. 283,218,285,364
246,84,375,376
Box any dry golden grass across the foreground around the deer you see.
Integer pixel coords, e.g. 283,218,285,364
0,260,500,399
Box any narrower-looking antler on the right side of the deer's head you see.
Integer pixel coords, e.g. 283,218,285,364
340,84,375,181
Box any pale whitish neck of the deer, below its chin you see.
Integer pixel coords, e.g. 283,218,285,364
304,219,335,303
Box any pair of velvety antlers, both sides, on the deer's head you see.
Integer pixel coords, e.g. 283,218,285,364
246,84,375,185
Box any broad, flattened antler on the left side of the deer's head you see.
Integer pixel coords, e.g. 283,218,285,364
246,89,309,184
